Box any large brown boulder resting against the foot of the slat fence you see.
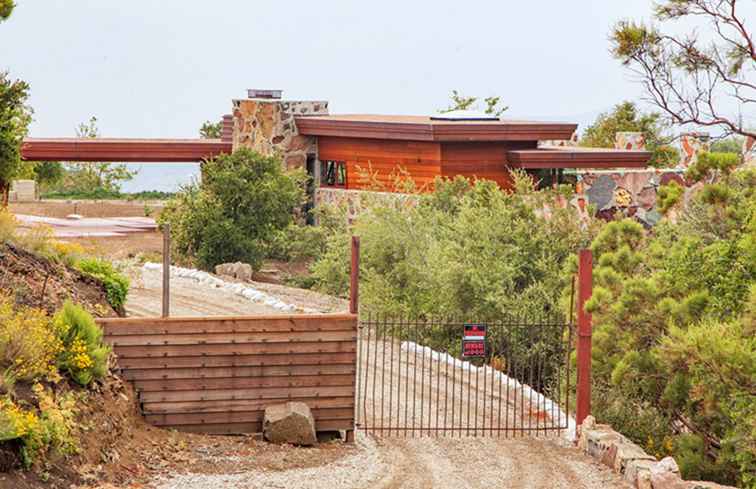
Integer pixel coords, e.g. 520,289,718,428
263,402,318,445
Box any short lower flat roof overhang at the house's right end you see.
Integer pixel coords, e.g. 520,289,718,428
507,148,651,169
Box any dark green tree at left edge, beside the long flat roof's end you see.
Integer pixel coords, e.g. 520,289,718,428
0,70,31,205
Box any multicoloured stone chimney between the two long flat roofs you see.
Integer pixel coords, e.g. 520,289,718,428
232,98,328,169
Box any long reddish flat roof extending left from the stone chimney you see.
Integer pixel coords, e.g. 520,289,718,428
21,138,231,163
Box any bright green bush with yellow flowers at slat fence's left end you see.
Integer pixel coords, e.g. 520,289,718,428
53,301,110,386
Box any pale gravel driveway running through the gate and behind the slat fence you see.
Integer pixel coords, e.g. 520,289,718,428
116,264,631,489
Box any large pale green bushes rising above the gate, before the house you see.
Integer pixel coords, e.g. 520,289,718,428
312,173,591,317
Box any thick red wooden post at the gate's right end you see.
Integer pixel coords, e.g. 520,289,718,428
575,250,593,426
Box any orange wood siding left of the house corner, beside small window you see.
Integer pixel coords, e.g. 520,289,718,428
318,137,441,191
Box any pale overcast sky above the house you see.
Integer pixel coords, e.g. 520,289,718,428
0,0,752,190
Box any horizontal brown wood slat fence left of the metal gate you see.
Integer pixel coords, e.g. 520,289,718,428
98,314,357,434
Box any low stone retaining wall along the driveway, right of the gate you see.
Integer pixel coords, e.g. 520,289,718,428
578,416,735,489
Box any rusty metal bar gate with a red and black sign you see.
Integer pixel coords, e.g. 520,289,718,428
357,313,574,437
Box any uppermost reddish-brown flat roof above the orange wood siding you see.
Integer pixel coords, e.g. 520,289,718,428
295,115,577,142
